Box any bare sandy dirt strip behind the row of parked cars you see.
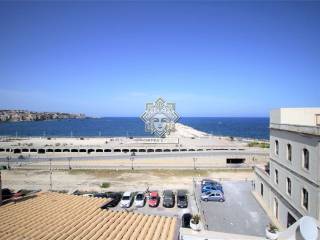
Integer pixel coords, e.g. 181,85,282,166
1,169,253,192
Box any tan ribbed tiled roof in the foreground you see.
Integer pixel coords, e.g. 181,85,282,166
0,193,177,240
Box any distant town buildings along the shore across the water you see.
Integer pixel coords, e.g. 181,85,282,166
0,110,86,122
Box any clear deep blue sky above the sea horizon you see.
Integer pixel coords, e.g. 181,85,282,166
0,1,320,116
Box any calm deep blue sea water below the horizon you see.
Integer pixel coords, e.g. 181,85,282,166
0,117,269,139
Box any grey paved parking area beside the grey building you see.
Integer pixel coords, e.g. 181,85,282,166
196,181,269,236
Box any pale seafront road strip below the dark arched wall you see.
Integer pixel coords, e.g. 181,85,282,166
0,150,268,170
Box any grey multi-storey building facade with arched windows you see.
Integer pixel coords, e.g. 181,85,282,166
254,108,320,228
